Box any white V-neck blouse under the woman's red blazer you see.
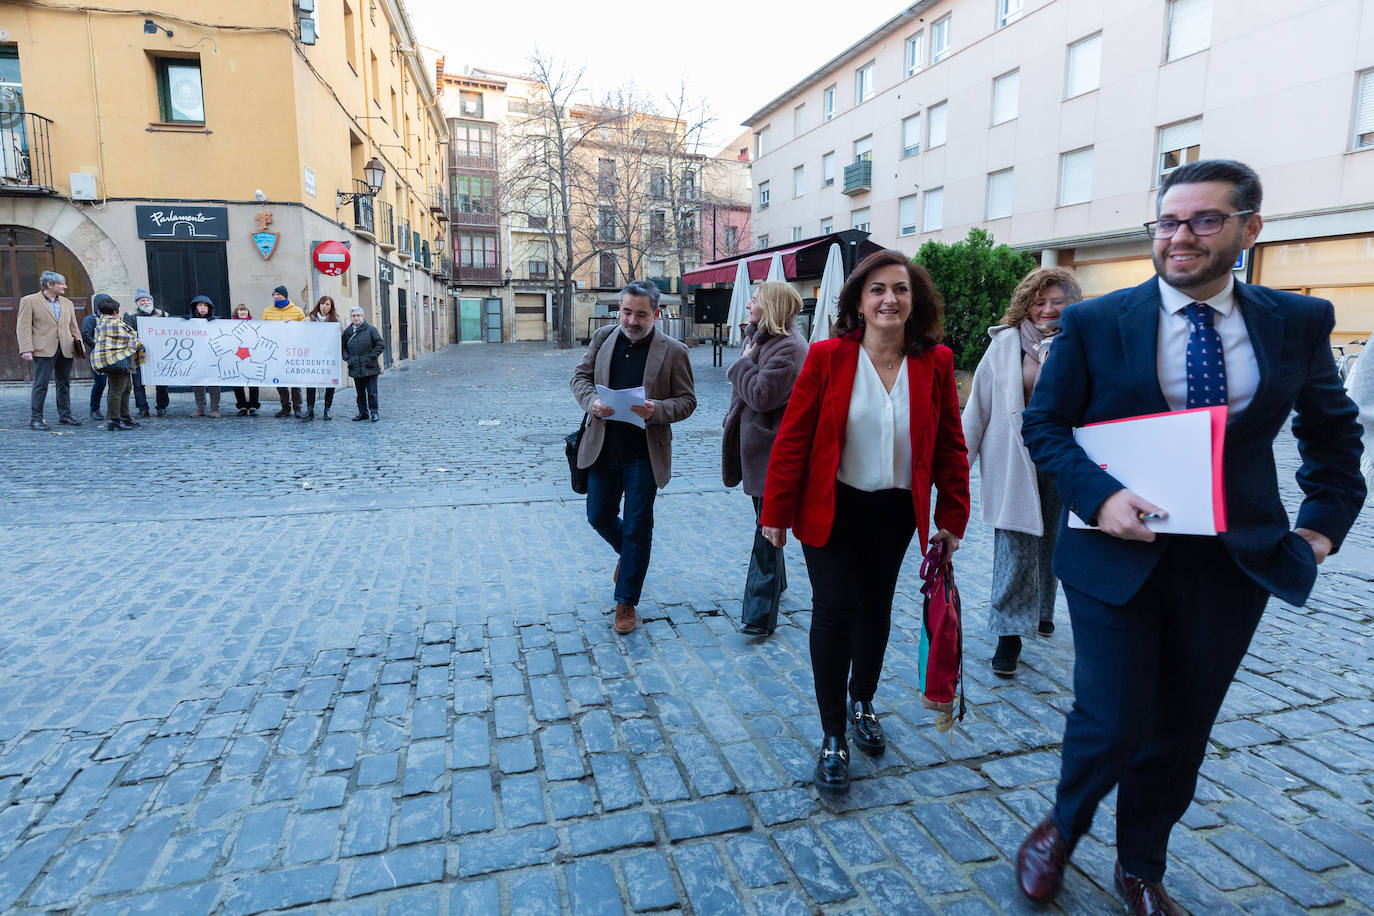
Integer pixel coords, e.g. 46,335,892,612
835,347,911,492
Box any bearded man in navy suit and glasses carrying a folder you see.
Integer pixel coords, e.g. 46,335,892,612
1017,159,1364,913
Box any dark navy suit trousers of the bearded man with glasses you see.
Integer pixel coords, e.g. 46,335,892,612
1054,534,1268,880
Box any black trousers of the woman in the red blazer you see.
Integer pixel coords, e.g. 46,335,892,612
801,483,916,736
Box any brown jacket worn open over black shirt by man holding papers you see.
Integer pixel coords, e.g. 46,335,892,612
572,324,697,489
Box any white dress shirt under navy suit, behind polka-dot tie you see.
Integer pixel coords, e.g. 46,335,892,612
1156,277,1260,416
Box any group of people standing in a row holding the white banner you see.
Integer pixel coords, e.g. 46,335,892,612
16,277,386,431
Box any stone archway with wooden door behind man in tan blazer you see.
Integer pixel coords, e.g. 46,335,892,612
0,196,131,380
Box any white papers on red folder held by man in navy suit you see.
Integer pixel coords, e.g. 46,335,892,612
1069,411,1216,534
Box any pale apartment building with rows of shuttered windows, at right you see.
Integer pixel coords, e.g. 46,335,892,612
745,0,1374,338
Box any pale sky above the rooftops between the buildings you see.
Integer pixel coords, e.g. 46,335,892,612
405,0,911,148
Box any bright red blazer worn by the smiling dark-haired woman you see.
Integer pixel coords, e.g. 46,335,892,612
761,336,969,552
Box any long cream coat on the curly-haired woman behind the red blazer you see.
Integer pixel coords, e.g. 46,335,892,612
963,324,1044,537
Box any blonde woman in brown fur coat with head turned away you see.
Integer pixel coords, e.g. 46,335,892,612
720,283,807,636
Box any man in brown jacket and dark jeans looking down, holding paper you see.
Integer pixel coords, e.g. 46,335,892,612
573,280,697,633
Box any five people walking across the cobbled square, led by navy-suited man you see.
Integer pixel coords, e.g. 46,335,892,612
572,159,1374,913
